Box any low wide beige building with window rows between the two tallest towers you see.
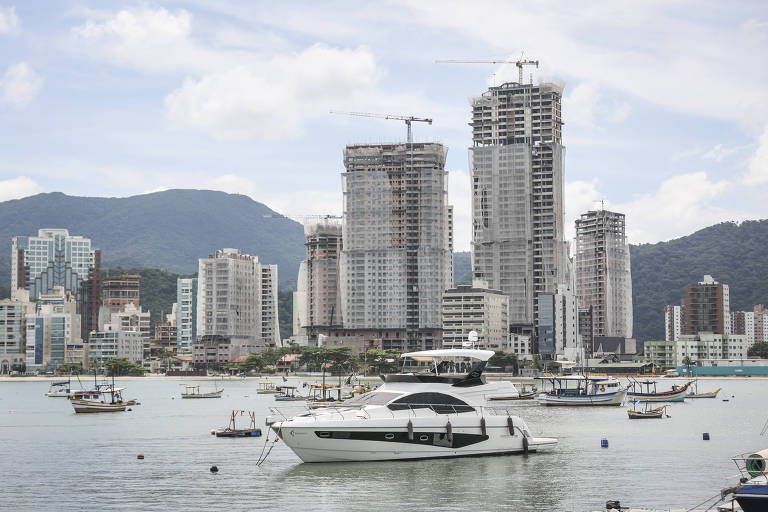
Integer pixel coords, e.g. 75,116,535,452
443,281,509,350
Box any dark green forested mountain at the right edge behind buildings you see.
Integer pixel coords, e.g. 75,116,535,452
630,220,768,341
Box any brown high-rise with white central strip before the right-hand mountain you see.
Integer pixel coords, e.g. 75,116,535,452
683,275,731,335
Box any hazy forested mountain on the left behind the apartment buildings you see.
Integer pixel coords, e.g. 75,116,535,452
0,190,305,288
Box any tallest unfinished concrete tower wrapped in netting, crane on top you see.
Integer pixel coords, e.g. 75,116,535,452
469,83,568,346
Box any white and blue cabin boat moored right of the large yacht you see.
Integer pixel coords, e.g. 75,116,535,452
537,375,627,406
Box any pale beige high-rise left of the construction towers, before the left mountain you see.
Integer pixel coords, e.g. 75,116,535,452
196,249,280,357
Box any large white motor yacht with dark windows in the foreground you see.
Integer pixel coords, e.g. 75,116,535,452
267,349,557,462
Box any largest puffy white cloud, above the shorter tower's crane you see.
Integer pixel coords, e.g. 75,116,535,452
165,44,379,139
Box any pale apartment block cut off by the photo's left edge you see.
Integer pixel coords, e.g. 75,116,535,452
0,290,35,374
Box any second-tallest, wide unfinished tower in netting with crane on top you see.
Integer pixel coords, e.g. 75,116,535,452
341,143,453,350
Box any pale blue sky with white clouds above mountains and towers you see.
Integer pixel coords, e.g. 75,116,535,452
0,0,768,250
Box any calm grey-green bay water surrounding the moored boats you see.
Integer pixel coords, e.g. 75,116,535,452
0,379,768,511
